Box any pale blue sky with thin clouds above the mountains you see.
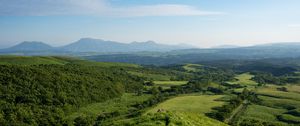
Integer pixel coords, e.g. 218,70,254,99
0,0,300,48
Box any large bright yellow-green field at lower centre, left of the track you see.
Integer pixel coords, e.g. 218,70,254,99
148,95,224,114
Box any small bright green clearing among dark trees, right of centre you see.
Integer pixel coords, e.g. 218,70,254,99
228,73,257,86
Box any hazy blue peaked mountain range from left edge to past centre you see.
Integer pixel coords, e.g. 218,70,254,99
0,38,193,55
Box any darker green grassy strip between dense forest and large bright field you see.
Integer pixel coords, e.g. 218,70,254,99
67,94,152,120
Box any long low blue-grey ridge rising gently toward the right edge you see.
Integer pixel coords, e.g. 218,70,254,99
85,43,300,65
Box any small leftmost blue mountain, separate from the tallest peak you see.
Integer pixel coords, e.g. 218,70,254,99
1,41,54,52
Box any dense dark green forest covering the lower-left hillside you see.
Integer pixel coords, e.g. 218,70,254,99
0,64,143,125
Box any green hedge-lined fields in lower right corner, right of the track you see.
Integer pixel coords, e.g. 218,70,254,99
239,85,300,125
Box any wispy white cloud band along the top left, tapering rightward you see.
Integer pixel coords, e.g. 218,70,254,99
0,0,223,17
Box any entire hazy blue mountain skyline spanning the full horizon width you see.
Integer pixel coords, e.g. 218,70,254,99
0,38,300,63
